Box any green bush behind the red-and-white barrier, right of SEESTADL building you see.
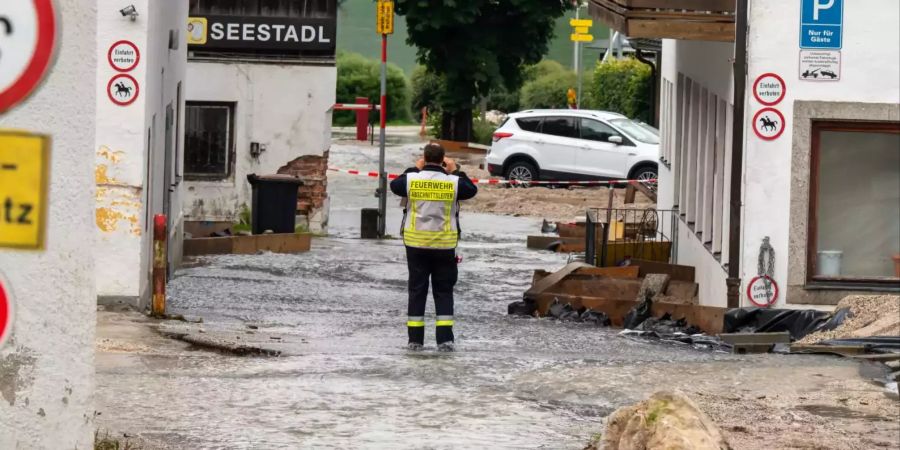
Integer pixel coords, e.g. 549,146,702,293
332,52,410,125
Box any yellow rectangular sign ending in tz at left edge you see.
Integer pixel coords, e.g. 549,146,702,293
0,131,50,250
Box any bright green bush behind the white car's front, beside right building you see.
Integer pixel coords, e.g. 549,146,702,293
588,58,653,122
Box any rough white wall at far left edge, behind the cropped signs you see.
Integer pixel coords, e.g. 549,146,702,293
0,0,97,449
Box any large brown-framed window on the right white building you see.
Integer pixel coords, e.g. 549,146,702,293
807,121,900,283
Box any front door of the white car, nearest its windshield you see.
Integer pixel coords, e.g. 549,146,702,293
576,118,637,179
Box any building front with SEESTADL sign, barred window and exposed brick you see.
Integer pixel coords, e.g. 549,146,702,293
184,0,337,231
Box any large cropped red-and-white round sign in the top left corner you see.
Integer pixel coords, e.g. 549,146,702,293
0,0,58,113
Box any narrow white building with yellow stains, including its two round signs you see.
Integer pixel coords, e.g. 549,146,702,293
93,0,188,309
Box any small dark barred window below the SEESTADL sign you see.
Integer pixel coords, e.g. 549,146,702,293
184,102,234,180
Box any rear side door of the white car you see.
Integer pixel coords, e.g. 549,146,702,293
538,117,579,180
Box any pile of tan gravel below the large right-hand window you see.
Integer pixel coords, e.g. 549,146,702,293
798,295,900,344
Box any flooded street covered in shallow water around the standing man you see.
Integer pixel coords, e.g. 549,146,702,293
96,134,896,449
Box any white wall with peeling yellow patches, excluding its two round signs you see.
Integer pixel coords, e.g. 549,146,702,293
94,0,187,302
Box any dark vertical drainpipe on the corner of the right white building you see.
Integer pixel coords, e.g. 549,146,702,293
726,0,748,308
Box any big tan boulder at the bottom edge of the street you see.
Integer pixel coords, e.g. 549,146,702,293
599,391,731,450
